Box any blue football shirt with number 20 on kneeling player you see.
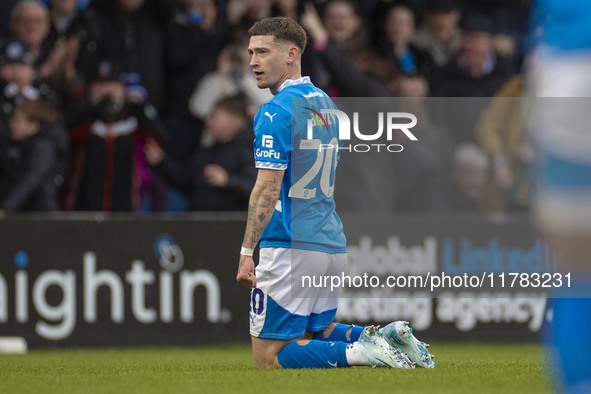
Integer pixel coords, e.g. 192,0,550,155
254,77,347,253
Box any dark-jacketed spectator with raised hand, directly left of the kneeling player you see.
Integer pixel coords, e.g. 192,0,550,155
145,97,256,211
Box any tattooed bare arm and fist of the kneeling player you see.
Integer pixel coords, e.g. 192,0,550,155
236,169,284,289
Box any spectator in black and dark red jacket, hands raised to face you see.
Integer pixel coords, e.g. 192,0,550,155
64,61,167,211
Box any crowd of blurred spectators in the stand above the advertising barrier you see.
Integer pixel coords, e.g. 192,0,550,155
0,0,534,212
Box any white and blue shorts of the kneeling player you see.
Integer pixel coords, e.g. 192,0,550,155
250,248,347,340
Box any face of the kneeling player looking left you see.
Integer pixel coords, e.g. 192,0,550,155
248,36,290,94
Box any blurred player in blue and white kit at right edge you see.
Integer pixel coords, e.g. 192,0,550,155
528,0,591,393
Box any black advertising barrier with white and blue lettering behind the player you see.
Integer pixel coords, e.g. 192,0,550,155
0,214,554,348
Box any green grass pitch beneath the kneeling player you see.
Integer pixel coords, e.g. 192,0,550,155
0,343,551,394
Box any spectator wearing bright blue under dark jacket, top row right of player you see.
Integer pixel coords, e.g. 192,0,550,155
379,4,433,76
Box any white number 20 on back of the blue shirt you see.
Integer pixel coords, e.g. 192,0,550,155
289,137,338,200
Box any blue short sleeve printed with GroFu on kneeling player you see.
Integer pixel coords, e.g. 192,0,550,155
253,103,291,170
